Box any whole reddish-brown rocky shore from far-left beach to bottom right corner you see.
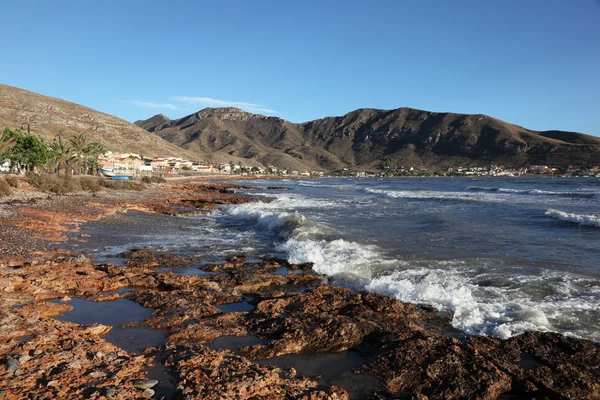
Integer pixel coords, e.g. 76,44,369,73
0,183,600,400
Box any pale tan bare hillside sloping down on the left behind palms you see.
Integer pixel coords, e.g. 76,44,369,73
0,84,193,158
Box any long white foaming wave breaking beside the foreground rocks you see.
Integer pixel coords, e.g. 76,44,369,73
221,192,600,338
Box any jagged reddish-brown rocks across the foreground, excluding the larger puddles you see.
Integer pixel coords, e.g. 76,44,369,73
0,244,600,400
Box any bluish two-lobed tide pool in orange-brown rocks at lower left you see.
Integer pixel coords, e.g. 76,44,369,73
53,298,166,353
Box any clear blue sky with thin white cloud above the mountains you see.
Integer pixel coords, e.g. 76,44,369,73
0,0,600,136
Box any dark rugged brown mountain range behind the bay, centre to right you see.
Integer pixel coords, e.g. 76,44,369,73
136,108,600,170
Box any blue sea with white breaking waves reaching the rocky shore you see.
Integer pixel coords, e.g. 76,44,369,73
94,178,600,341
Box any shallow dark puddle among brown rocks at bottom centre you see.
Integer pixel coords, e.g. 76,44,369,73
256,351,379,400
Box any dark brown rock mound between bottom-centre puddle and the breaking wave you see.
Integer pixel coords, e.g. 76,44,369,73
245,286,423,359
